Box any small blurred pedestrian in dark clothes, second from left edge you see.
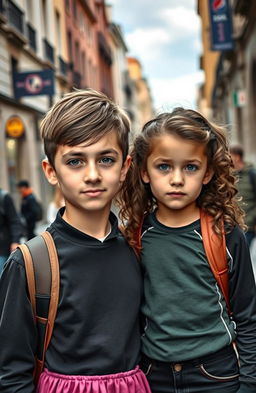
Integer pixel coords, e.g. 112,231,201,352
17,180,38,240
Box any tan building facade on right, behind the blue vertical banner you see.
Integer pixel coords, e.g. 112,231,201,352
198,0,256,161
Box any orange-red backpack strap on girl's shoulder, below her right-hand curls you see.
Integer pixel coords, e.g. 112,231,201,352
200,209,232,315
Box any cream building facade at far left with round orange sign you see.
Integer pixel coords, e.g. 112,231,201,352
0,0,70,205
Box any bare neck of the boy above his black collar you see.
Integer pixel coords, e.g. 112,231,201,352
62,209,111,239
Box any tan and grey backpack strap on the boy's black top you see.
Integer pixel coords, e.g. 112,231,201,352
19,231,60,383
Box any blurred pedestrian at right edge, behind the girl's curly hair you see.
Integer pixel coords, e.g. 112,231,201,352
230,145,256,246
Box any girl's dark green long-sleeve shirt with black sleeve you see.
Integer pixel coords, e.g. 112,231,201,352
142,213,256,391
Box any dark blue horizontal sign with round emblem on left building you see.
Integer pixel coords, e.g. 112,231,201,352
13,69,54,98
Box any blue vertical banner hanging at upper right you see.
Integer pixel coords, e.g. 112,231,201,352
209,0,234,51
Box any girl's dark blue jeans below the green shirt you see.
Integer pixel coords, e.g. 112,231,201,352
140,346,239,393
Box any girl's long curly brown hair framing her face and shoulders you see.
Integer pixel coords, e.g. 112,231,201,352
117,108,245,249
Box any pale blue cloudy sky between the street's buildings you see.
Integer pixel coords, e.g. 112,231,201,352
108,0,203,112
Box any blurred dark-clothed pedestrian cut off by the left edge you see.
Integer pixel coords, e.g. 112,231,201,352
0,188,22,274
